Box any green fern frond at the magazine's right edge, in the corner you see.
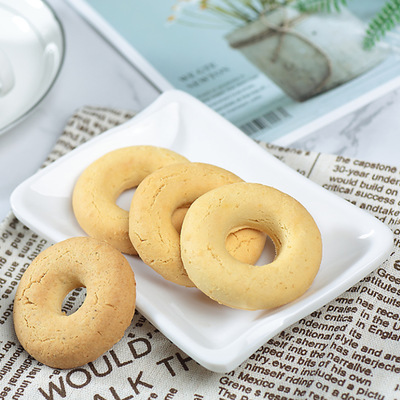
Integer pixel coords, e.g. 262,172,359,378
364,0,400,49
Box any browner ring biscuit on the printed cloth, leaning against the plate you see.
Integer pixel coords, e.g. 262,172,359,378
14,237,136,368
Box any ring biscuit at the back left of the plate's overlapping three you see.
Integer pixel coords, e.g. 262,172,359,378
72,146,187,255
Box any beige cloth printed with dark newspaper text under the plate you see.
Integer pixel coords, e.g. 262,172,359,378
0,107,400,400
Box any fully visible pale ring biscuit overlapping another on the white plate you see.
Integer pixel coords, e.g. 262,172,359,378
181,183,322,310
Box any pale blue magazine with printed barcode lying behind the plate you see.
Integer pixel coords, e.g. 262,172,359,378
66,0,400,145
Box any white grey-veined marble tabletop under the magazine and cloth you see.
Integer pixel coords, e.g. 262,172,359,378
0,0,400,220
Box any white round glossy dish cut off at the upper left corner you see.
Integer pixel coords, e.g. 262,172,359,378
0,0,65,133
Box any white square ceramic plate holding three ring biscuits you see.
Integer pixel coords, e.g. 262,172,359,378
11,90,393,372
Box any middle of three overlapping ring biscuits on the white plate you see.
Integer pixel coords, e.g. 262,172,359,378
129,163,265,287
